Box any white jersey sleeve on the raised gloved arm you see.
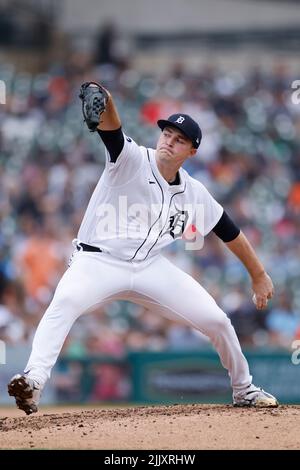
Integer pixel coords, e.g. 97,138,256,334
105,133,143,185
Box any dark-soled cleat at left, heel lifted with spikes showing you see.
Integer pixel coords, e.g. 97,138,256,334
7,374,42,415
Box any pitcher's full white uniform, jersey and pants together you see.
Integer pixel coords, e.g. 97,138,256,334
25,130,252,390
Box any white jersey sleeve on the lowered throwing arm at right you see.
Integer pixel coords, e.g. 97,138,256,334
194,181,224,236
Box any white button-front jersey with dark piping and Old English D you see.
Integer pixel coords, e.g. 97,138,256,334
78,135,223,261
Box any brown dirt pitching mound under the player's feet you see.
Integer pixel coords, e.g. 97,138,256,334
0,404,300,450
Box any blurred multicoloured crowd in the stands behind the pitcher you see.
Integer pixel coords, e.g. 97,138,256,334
0,54,300,360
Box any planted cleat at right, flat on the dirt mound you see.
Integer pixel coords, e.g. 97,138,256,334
233,384,278,408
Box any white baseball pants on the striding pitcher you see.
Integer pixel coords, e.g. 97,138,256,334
25,251,252,391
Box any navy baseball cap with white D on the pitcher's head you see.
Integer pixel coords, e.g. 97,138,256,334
157,114,202,149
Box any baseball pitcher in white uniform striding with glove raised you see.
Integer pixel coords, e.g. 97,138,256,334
8,82,278,414
